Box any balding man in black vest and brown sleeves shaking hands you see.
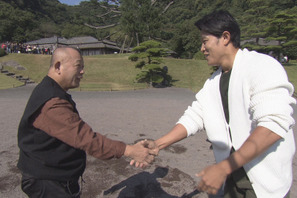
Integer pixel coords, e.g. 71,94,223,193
18,47,154,198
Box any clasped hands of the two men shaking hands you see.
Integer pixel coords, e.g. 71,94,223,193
124,139,160,168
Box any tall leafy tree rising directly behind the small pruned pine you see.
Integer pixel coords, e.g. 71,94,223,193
84,0,175,48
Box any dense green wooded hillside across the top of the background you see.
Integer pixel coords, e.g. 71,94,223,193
0,0,297,59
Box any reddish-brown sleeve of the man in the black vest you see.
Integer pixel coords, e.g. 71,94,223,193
33,98,126,159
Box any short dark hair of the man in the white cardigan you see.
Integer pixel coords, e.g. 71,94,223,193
195,10,240,48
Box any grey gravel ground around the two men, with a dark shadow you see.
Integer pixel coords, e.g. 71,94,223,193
0,85,297,198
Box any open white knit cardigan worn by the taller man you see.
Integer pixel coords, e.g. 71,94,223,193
178,49,296,198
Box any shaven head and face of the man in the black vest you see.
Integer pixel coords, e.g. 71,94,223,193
48,47,84,91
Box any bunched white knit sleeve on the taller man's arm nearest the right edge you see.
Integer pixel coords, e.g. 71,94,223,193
250,59,296,137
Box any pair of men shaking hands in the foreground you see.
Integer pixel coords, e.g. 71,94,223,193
18,10,296,198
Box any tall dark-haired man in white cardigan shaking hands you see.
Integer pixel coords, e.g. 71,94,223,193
135,11,296,198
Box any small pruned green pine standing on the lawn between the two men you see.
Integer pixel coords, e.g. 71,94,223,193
129,40,171,86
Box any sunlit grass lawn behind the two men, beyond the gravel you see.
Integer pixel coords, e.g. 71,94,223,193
0,54,297,92
